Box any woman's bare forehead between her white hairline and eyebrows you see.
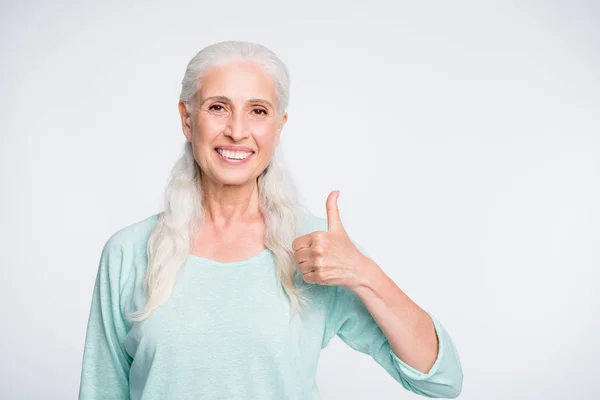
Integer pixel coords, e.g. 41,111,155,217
198,62,275,103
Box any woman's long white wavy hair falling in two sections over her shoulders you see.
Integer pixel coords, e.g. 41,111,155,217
129,41,307,321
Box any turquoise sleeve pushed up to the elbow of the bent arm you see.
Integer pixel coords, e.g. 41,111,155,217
323,245,463,398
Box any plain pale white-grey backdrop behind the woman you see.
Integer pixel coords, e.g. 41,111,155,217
0,0,600,400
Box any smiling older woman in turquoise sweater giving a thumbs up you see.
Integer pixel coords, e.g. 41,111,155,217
79,41,462,400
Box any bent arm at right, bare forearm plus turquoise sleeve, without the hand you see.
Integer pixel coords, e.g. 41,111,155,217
323,243,463,398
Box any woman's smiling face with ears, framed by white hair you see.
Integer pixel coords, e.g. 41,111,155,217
179,62,287,189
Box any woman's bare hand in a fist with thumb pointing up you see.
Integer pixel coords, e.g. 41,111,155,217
292,190,372,289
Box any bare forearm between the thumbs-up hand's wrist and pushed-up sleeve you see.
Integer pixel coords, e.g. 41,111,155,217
352,259,438,373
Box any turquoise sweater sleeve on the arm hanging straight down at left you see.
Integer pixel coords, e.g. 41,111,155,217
79,236,132,400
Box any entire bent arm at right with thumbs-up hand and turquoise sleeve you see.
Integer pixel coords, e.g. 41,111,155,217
292,203,463,398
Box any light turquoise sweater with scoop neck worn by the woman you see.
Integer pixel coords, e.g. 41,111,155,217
79,214,462,400
